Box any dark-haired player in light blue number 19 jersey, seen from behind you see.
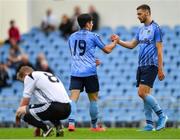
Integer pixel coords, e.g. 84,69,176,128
68,14,118,131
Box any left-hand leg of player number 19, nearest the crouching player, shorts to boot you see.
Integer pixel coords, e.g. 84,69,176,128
68,76,83,131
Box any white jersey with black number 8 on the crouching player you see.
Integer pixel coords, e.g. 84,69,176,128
24,71,70,103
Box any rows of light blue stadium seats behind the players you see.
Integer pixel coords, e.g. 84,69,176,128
0,25,180,122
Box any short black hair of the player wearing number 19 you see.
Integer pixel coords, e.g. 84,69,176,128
77,14,93,28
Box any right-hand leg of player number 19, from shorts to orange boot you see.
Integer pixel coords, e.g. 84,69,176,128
85,75,105,131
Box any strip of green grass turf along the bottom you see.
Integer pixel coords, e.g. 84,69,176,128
0,128,180,140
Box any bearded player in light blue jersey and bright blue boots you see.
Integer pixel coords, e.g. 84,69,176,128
111,4,168,131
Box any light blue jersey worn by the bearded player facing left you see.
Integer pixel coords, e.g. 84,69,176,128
135,21,162,66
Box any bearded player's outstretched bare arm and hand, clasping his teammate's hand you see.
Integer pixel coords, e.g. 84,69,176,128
111,34,138,49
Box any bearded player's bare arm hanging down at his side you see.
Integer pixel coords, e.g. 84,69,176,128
156,42,165,81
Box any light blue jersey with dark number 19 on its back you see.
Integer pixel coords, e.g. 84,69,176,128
68,29,105,77
